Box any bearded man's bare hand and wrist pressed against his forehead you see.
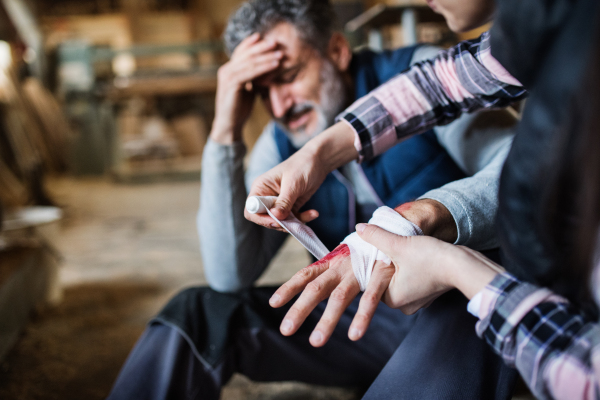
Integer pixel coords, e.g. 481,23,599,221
210,33,283,144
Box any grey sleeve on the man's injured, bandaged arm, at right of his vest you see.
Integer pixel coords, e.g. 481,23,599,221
411,46,516,250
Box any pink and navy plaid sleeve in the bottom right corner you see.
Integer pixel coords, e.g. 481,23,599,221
477,273,600,400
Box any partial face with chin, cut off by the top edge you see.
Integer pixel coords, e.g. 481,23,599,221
427,0,495,32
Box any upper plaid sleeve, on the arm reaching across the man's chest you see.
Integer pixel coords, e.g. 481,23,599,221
338,33,527,161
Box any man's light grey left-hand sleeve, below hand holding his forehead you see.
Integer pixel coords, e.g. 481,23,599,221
197,125,287,292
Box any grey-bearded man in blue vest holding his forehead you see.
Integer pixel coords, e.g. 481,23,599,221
110,0,515,399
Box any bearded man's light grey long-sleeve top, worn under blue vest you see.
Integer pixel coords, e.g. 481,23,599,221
198,47,515,292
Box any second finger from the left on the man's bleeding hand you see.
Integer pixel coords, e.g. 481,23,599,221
280,270,342,336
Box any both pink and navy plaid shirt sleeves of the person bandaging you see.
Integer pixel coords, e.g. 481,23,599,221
339,33,600,400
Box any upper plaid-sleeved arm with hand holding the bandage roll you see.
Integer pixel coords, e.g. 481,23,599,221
246,33,527,227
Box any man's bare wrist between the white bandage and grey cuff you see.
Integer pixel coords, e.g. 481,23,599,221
395,199,458,243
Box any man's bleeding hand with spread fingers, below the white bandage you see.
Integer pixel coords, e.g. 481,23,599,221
269,244,394,347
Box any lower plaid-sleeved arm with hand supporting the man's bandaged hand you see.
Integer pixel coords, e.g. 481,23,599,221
350,225,600,400
